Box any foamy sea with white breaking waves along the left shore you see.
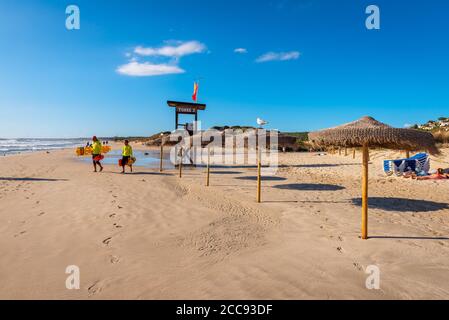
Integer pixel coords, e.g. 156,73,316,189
0,138,89,156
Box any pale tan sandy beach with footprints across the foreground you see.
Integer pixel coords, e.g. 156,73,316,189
0,146,449,299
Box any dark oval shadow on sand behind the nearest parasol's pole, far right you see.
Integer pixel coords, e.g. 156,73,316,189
351,197,449,212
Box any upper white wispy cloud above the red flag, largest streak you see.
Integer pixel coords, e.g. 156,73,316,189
134,41,206,58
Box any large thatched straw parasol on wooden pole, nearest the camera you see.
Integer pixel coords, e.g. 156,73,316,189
309,117,438,239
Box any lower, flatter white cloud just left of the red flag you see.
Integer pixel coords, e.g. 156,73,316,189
116,61,185,77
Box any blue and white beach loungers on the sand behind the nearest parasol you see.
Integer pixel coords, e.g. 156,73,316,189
384,153,430,176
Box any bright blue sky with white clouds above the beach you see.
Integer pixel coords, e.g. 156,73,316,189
0,0,449,137
